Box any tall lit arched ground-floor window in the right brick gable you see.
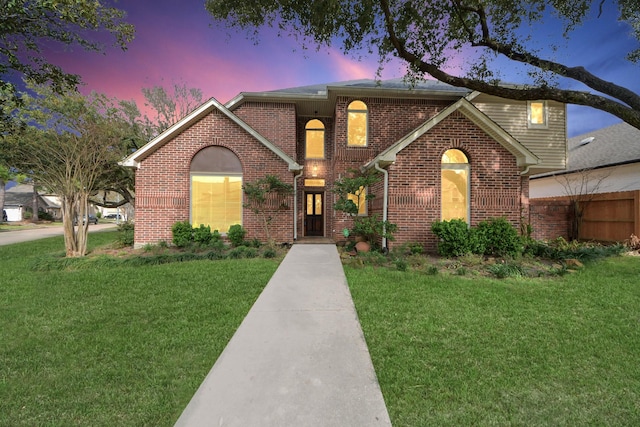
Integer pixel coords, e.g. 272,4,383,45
440,149,470,223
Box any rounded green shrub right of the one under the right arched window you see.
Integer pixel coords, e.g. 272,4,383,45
474,217,523,257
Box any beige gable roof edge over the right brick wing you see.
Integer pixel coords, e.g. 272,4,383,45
364,97,540,169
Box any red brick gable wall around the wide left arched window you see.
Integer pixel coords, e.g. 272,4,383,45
135,110,295,246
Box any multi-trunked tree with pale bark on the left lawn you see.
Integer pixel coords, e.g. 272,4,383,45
2,85,131,256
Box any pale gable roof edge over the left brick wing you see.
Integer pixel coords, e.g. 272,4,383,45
120,98,302,171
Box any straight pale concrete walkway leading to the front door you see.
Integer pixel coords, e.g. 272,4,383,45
176,244,391,427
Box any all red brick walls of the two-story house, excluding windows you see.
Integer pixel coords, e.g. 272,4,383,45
135,97,535,251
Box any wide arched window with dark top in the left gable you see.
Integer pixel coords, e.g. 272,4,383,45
190,146,242,233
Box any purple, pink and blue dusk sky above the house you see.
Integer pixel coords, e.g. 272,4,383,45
45,0,640,137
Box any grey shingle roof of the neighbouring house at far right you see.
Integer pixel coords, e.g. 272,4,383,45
567,122,640,171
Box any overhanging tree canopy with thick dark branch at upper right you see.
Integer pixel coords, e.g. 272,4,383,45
206,0,640,129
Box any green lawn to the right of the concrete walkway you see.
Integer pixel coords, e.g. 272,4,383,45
345,257,640,427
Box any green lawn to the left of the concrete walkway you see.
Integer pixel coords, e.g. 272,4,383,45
0,232,277,426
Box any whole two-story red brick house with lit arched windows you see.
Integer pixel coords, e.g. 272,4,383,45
123,79,566,250
